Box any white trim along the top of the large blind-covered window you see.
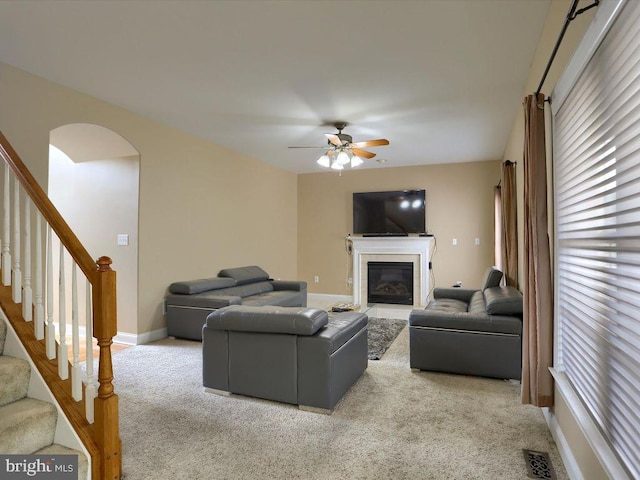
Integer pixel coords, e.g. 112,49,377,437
551,0,626,115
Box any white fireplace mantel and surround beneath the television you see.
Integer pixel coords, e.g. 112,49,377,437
348,237,433,307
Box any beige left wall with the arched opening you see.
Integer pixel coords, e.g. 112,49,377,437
0,63,297,340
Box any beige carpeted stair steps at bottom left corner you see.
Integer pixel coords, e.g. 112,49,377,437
0,319,88,480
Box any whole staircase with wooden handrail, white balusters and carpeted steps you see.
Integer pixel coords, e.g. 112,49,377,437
0,132,122,480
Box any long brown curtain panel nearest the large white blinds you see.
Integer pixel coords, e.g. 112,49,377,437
522,94,553,407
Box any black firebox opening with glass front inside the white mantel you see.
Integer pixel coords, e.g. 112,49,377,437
367,262,413,305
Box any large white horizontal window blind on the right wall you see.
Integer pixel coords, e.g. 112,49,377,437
553,1,640,478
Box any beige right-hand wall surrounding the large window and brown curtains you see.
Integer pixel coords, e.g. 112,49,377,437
503,0,607,480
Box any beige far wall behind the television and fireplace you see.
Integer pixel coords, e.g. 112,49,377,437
298,159,500,295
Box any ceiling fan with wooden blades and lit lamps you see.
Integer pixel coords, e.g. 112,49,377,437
289,122,389,170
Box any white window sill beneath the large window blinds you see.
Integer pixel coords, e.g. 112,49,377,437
549,368,632,480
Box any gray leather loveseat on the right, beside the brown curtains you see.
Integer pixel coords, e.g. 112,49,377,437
409,268,523,379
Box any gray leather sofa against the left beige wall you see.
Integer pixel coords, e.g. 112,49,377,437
165,266,307,340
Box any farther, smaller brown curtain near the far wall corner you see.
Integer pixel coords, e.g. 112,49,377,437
502,160,518,288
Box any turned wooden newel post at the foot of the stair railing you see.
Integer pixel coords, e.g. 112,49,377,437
93,257,122,480
